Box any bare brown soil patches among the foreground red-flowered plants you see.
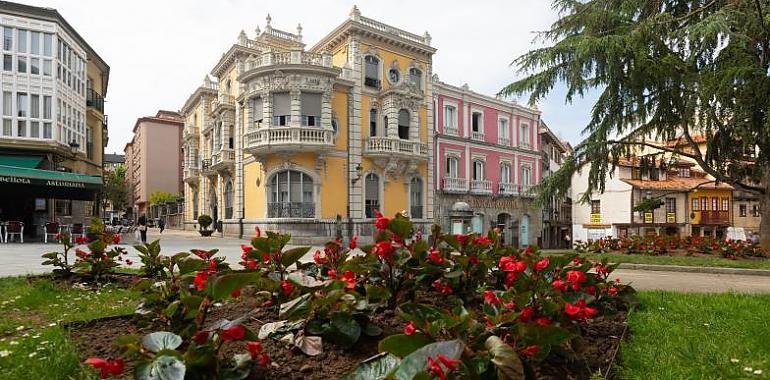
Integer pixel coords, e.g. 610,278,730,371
71,294,625,380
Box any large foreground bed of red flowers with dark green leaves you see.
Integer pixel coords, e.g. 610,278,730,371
45,215,634,380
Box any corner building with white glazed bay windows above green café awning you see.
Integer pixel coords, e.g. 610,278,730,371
0,1,110,235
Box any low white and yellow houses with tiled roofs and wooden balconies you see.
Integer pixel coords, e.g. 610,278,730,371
572,155,733,241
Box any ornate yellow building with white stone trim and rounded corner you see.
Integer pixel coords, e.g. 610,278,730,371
182,7,435,240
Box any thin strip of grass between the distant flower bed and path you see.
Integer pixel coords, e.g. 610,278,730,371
545,251,770,269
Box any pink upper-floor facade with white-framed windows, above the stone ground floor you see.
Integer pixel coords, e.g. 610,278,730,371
434,84,542,195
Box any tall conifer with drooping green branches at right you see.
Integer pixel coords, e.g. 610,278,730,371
501,0,770,248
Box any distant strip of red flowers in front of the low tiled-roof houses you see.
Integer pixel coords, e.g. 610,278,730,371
575,236,767,260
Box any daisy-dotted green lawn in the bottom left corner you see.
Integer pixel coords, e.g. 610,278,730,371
0,277,138,380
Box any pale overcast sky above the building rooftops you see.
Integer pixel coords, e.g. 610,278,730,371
13,0,595,153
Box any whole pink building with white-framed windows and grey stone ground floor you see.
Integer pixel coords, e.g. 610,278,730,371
433,78,543,246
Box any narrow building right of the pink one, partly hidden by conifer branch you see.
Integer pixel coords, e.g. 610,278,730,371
539,119,572,249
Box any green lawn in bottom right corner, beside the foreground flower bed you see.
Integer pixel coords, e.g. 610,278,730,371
619,292,770,379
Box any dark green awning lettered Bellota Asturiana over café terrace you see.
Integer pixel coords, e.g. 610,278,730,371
0,162,102,189
